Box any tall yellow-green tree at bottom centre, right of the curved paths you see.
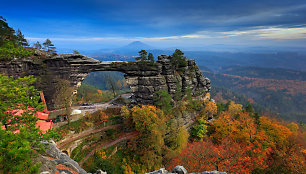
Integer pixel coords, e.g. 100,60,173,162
121,105,165,173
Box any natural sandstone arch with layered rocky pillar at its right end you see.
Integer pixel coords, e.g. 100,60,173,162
0,54,210,110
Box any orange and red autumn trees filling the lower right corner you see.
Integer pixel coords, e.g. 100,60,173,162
166,102,306,173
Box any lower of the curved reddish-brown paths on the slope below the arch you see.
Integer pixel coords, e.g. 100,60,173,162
79,131,138,166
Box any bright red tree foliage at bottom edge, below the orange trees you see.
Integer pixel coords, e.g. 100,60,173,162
167,140,267,173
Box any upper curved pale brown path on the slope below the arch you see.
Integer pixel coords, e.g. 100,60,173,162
57,124,121,149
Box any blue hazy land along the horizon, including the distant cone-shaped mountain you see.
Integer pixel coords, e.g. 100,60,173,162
85,47,306,72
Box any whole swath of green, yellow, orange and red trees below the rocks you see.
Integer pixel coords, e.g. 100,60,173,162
65,89,305,173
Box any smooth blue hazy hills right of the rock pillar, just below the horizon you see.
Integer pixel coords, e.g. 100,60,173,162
185,51,306,71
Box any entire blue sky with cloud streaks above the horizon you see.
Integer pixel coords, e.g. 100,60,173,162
0,0,306,50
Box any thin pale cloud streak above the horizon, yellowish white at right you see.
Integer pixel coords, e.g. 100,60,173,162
27,27,306,42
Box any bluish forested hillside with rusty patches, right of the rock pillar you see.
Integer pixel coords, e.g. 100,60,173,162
204,67,306,122
